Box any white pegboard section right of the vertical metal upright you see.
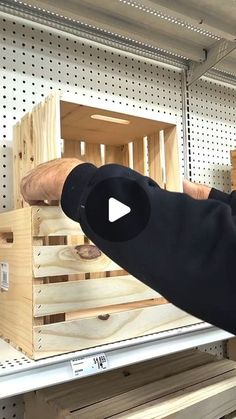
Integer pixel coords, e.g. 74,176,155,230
188,79,236,192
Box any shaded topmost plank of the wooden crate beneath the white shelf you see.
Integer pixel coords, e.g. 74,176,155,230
25,350,216,419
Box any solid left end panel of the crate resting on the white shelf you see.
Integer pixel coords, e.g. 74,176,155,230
0,208,33,355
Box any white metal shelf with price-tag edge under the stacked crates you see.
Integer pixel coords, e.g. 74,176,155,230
0,323,232,399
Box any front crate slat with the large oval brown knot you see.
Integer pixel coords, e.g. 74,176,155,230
33,245,119,278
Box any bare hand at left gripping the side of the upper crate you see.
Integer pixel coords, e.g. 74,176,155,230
20,158,82,205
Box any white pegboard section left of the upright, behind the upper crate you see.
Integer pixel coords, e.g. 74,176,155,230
0,16,183,211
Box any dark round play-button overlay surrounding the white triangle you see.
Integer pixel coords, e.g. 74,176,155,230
83,177,151,242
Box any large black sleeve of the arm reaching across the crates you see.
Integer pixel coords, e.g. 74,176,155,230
61,163,236,334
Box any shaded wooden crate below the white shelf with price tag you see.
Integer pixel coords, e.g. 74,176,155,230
25,350,236,419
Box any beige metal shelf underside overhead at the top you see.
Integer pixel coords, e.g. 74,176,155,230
0,0,236,84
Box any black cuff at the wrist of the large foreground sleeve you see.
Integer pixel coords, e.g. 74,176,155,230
61,163,97,222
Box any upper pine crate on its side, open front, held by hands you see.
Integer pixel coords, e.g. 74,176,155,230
13,92,180,208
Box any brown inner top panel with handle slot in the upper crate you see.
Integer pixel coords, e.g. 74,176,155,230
60,100,171,145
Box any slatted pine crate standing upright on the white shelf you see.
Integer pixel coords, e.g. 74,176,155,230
0,207,199,359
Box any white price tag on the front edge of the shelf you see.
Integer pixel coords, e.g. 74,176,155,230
71,353,108,377
